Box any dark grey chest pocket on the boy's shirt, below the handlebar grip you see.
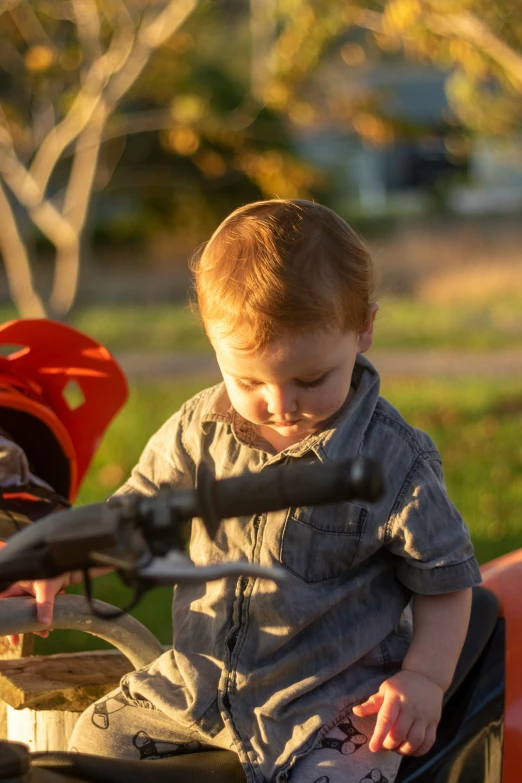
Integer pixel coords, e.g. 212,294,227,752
280,503,368,582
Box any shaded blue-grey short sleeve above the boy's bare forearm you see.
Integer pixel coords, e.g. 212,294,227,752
385,455,482,595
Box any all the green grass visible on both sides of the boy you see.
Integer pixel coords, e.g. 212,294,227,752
37,378,522,653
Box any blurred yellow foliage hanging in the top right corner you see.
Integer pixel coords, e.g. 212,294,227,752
353,0,522,135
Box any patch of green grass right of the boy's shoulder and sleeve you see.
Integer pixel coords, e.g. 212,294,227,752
383,378,522,562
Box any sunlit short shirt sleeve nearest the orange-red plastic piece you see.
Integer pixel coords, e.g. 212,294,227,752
112,411,195,497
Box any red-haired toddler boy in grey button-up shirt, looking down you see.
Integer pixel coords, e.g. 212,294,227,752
10,200,480,783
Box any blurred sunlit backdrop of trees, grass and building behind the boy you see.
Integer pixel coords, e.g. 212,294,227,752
0,0,522,652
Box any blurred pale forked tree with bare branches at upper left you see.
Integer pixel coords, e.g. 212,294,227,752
0,0,197,316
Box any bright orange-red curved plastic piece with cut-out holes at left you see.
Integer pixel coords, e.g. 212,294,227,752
0,319,128,502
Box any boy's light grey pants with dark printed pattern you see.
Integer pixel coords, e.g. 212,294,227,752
69,688,401,783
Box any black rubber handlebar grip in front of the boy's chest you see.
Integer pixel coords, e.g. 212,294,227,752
198,459,384,519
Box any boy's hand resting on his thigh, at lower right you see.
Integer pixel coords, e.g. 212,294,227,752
353,669,444,756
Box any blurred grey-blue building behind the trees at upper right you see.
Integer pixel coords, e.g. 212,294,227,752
298,54,522,216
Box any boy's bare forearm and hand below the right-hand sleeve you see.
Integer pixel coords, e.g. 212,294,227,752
353,589,471,756
